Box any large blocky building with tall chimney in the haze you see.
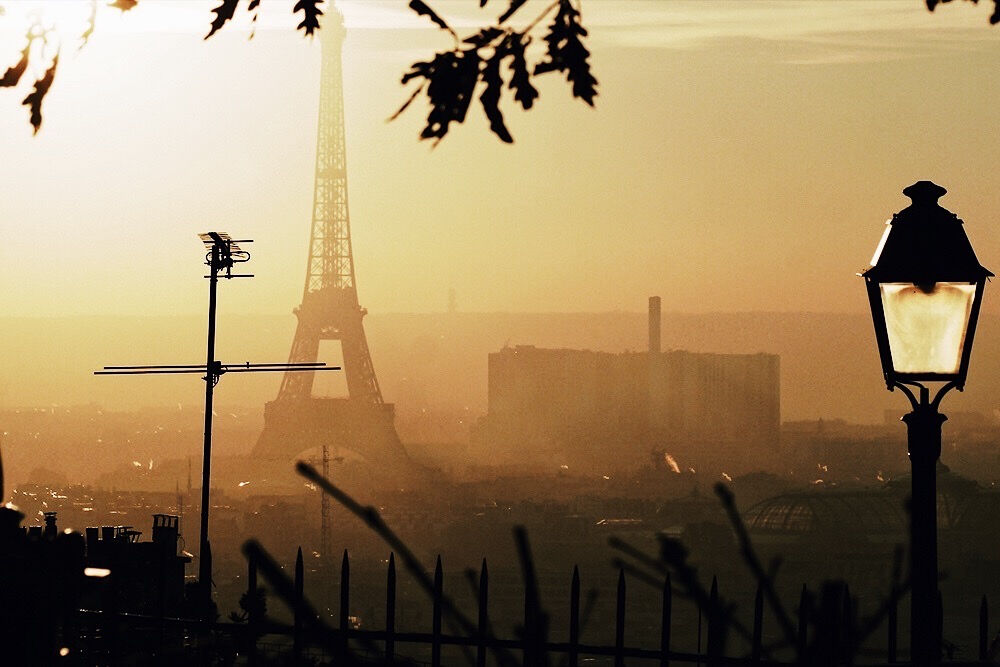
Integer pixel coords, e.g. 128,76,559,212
476,300,781,472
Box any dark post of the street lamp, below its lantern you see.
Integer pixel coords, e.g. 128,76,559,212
903,387,947,665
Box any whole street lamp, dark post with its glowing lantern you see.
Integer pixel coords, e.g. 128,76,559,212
860,181,993,665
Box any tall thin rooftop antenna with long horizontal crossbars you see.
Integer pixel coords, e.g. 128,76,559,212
94,232,340,613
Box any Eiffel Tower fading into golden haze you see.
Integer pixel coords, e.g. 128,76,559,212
253,7,408,468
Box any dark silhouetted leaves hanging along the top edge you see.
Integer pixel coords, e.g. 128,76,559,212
0,0,1000,137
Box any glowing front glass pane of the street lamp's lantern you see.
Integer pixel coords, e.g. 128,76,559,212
879,283,976,375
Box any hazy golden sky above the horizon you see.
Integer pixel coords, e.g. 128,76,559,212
0,0,1000,316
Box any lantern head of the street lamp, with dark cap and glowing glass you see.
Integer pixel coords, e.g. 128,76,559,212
861,181,993,390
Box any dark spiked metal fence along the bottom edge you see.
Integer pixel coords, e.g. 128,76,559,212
72,549,990,667
